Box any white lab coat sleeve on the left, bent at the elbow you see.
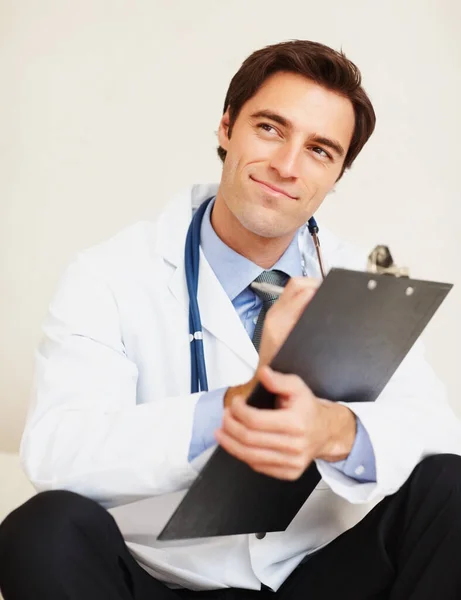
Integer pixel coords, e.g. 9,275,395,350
20,253,200,506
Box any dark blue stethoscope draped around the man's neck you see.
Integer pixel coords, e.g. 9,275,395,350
184,196,325,394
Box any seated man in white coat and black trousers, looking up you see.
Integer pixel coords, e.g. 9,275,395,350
0,41,461,600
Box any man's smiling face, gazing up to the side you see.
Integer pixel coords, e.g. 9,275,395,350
218,73,355,238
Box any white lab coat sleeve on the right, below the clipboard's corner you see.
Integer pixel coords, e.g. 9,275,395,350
316,343,461,504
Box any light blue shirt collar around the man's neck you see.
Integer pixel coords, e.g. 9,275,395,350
200,199,302,302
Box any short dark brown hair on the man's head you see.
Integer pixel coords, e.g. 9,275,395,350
218,40,376,179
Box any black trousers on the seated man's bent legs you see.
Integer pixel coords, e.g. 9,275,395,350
0,454,461,600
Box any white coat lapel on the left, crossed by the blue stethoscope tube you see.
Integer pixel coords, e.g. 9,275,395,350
157,185,258,369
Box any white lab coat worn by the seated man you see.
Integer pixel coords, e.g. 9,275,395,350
21,186,461,589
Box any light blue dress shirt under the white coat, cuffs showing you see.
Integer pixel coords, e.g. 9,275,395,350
189,201,376,482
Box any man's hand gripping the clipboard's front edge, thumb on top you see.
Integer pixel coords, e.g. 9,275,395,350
215,366,356,480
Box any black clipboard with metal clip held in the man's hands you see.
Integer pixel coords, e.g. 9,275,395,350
158,269,452,540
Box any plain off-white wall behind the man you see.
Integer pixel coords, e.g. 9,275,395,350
0,0,461,450
